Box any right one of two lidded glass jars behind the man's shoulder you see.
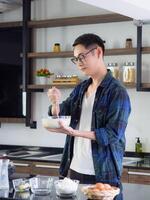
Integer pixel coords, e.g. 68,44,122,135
123,62,135,83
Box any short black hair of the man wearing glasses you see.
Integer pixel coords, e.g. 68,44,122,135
72,33,105,55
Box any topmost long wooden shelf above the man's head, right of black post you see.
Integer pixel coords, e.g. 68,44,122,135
28,14,133,28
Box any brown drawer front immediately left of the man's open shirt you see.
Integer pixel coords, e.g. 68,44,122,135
32,162,59,176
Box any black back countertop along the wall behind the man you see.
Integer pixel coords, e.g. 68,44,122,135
0,145,150,170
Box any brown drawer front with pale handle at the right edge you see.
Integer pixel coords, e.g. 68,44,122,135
128,169,150,185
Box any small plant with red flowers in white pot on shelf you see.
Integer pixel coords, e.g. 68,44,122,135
36,68,54,84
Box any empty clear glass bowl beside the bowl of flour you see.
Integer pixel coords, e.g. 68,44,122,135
29,176,53,195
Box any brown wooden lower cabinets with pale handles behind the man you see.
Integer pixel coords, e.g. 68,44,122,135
11,159,150,185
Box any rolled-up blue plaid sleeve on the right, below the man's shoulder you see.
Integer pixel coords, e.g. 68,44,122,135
94,89,131,146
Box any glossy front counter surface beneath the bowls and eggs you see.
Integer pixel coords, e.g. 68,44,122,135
0,183,150,200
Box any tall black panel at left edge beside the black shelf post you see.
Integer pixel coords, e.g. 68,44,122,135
0,28,22,117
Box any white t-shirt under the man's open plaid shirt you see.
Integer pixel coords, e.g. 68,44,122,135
70,92,95,175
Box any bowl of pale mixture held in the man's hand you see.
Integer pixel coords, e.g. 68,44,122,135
42,116,71,128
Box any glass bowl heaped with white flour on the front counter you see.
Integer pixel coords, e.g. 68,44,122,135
54,178,79,198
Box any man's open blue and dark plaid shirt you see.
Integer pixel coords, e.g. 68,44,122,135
49,72,131,184
